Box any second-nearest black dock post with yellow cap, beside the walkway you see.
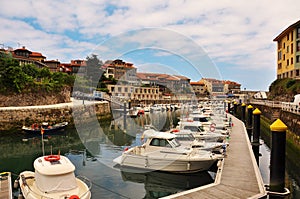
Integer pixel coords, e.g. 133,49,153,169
252,108,261,165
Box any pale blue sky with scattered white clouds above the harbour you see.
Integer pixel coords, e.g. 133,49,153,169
0,0,300,91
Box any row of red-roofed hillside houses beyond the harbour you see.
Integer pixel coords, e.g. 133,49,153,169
0,46,241,100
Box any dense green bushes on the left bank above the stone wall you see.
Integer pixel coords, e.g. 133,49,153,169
0,52,75,94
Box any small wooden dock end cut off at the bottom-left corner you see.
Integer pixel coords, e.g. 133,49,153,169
0,172,12,199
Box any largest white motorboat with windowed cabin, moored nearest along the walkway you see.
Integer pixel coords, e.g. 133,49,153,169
113,129,223,173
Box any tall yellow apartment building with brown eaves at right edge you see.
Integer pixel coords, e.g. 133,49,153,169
273,20,300,79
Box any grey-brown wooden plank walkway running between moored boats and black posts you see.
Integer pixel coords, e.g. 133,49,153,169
164,116,266,199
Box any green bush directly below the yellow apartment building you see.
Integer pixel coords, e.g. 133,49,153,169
268,78,300,101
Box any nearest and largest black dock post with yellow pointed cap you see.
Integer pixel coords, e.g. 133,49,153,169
268,119,290,198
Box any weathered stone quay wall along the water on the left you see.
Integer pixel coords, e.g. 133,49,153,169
0,101,110,131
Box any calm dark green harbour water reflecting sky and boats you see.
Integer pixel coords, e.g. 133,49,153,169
0,111,300,199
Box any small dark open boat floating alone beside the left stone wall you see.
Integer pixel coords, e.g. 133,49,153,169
22,122,68,134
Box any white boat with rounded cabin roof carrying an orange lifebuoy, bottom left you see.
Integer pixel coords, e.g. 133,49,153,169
18,155,92,199
